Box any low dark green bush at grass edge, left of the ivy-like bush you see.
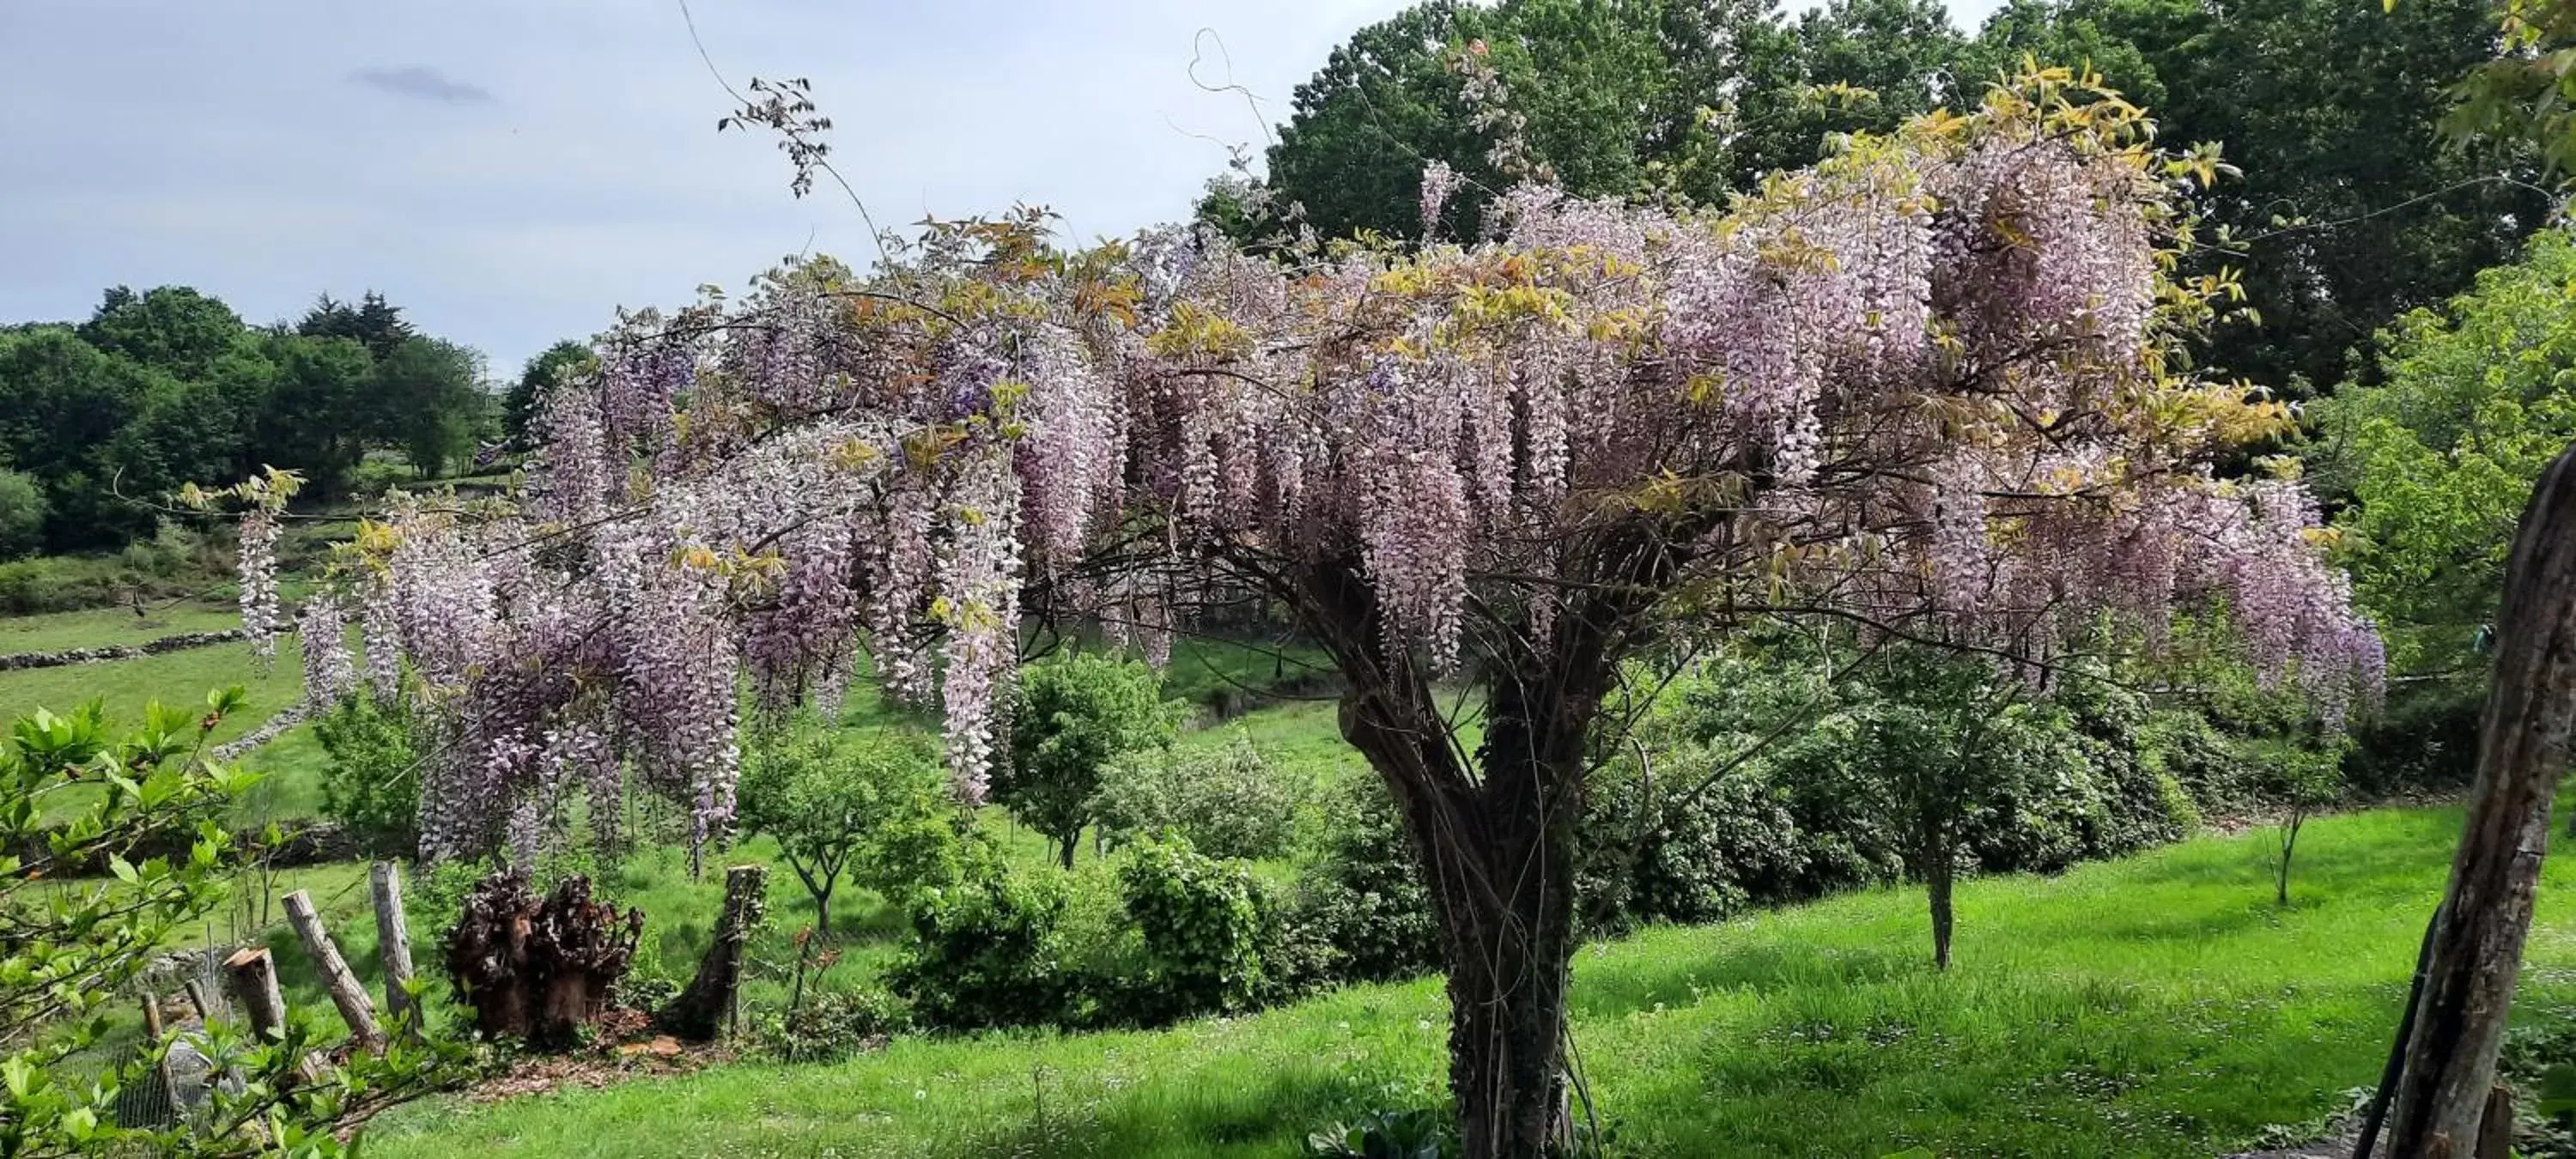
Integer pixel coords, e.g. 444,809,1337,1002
886,873,1074,1030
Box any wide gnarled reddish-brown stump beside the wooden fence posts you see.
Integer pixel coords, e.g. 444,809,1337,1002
446,871,644,1048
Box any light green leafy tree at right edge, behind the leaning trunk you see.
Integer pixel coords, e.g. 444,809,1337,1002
2311,229,2576,672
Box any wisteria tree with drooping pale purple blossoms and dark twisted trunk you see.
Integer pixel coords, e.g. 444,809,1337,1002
276,72,2378,1156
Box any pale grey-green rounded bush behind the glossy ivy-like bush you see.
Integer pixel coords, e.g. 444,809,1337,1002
1092,734,1311,860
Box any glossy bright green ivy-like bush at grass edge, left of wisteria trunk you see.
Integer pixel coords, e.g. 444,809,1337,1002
1108,840,1262,1022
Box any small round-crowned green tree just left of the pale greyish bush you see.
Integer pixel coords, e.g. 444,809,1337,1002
992,652,1185,868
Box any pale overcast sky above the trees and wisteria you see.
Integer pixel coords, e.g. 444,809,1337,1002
0,0,1989,376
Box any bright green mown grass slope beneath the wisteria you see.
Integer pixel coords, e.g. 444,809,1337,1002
371,811,2576,1156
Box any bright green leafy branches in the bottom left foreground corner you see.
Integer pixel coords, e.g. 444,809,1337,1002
0,688,466,1159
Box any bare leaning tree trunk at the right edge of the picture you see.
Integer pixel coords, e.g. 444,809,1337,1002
2388,446,2576,1159
